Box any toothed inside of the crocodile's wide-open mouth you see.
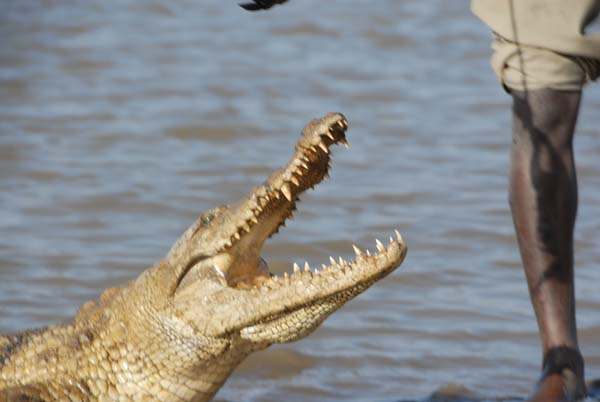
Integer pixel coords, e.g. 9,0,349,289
210,113,403,289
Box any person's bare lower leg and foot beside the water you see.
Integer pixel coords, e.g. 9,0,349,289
510,89,585,402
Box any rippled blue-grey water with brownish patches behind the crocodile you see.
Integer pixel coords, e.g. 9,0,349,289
0,0,600,402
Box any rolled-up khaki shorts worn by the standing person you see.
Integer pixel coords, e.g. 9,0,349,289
471,0,600,90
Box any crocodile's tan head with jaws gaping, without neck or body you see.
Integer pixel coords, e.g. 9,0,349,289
162,114,406,348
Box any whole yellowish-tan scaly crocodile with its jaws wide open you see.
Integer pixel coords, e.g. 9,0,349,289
0,113,406,402
